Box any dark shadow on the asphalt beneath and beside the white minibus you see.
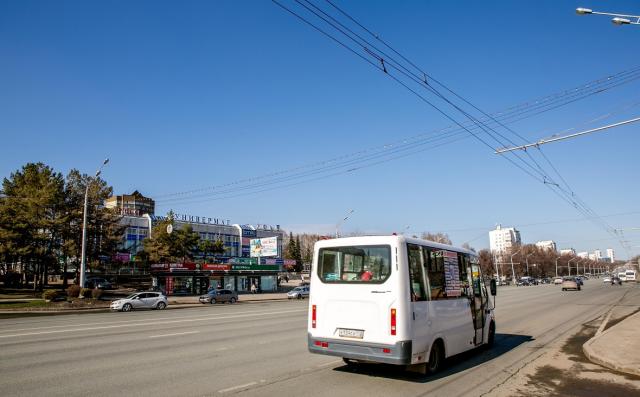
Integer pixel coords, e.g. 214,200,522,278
333,333,535,383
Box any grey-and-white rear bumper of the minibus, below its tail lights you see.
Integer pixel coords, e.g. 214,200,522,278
307,334,411,365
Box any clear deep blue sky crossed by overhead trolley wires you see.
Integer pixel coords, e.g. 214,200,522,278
0,0,640,257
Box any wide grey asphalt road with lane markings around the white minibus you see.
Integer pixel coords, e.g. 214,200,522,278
0,280,640,397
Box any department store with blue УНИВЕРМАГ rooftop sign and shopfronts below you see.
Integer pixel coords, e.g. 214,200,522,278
105,191,291,295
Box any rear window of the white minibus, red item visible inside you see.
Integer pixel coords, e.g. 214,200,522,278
318,245,391,284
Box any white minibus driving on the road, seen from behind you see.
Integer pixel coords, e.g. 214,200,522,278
308,235,496,372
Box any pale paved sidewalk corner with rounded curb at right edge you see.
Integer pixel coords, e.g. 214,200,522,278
582,313,640,376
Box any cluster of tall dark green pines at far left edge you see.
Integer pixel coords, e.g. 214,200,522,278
0,163,124,289
